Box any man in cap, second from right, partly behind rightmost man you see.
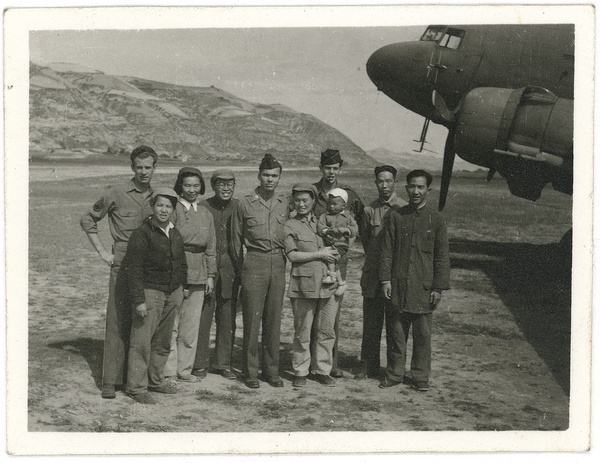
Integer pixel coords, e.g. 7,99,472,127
355,165,407,379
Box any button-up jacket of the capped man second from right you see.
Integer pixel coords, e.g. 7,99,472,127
360,193,407,298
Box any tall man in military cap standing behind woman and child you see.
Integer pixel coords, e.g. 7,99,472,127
311,148,364,378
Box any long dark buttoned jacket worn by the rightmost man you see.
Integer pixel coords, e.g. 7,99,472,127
379,205,450,313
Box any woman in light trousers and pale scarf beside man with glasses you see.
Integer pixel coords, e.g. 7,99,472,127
165,167,217,383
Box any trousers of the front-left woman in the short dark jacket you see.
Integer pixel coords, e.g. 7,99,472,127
127,287,183,395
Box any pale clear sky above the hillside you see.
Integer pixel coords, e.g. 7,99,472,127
29,25,447,154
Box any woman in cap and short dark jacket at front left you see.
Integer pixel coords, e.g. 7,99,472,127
122,188,187,404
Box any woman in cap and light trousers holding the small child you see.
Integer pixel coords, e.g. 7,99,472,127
284,183,339,387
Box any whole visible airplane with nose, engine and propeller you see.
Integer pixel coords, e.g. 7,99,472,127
367,24,575,203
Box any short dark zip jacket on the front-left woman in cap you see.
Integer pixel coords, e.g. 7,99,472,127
122,217,187,307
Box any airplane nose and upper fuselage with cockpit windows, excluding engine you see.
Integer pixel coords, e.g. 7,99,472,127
367,24,575,125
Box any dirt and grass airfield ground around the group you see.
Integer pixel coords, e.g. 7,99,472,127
28,165,571,432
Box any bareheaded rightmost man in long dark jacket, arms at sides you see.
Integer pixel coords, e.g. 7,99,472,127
379,170,450,392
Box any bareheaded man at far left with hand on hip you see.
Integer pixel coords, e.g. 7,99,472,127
80,146,158,399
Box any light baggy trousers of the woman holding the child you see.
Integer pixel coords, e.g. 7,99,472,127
290,296,339,376
